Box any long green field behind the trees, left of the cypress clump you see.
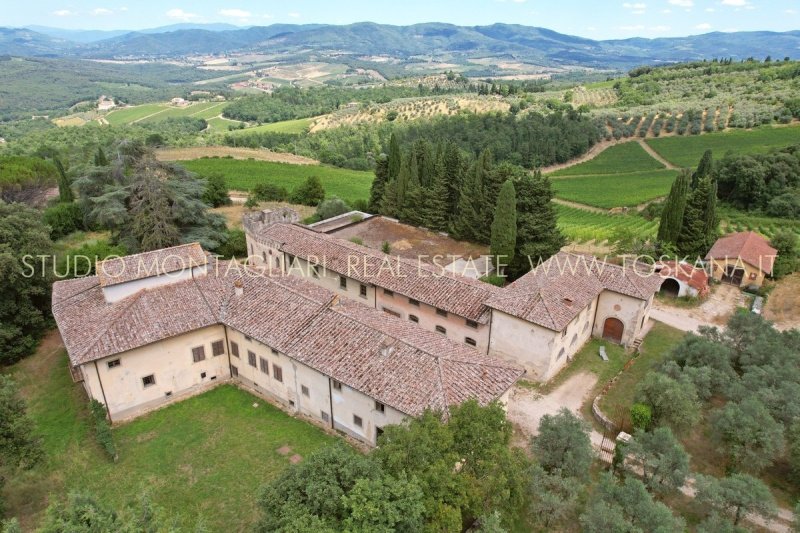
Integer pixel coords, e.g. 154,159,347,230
181,158,375,202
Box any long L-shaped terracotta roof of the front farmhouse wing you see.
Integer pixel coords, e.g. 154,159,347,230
53,256,524,415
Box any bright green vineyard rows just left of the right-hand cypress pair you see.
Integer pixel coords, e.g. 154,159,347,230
555,204,658,242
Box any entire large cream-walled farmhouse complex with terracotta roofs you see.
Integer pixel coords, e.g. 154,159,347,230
53,208,661,444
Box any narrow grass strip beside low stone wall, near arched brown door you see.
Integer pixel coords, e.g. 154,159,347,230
600,322,685,431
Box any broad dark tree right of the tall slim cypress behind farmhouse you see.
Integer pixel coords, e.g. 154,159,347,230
510,170,567,277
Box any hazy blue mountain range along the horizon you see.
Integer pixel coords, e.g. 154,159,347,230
0,22,800,68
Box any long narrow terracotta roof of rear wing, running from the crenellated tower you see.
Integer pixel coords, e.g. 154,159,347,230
256,224,501,324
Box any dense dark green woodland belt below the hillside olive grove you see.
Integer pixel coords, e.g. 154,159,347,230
223,111,605,170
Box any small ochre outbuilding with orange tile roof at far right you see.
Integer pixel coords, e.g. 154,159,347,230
705,231,778,287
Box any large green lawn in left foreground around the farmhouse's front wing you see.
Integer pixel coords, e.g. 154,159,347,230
4,335,335,531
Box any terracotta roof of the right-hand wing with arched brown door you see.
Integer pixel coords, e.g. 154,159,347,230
487,252,661,331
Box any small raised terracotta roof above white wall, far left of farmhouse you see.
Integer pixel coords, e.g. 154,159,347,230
97,242,208,287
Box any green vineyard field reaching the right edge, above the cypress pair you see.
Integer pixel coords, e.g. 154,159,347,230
646,126,800,167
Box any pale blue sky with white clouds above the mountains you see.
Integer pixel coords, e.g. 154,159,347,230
6,0,800,39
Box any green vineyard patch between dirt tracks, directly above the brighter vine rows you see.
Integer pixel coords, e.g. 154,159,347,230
550,171,678,209
